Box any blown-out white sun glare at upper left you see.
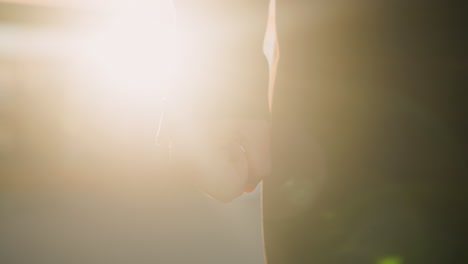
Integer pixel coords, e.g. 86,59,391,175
72,1,174,92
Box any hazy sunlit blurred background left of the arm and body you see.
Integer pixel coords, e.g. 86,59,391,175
0,1,263,264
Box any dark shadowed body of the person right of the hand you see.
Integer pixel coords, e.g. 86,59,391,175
263,0,468,264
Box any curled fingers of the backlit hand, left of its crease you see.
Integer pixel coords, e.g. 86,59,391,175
174,123,248,202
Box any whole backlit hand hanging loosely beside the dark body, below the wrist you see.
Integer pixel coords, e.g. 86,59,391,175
172,120,271,202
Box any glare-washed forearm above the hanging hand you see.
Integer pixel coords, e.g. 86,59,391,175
171,1,270,119
